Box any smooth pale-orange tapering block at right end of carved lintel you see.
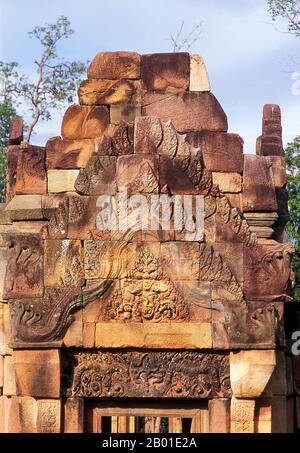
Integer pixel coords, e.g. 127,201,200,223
230,350,276,398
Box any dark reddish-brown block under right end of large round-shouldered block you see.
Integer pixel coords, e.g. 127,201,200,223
197,132,244,173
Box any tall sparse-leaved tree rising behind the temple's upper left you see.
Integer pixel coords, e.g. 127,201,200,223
0,16,86,142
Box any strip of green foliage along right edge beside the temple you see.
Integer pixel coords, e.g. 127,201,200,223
285,139,300,299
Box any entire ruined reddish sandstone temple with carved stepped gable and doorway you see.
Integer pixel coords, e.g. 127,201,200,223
0,52,300,433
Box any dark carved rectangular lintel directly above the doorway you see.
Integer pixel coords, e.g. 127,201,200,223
66,352,231,398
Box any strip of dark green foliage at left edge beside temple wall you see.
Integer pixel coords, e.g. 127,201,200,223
0,98,19,203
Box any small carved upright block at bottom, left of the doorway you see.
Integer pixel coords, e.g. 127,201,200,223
37,399,61,433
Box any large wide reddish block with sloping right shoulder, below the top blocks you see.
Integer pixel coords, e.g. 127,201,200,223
142,92,228,132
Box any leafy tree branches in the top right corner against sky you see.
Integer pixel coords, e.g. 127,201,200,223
267,0,300,37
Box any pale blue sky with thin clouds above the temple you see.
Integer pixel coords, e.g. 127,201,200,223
0,0,300,153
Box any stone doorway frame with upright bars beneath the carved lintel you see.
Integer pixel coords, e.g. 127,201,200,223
85,400,209,434
